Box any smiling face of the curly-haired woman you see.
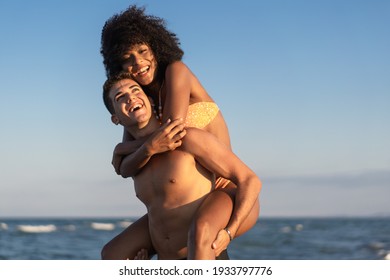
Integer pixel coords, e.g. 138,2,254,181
122,44,157,86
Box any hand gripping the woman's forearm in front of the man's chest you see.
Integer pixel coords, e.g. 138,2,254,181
145,119,186,156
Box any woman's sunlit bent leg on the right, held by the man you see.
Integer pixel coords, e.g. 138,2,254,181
188,183,259,259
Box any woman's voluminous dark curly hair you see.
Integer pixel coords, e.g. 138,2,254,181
100,5,184,77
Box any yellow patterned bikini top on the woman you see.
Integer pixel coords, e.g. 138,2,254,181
185,102,219,128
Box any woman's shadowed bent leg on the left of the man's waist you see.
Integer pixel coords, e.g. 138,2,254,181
101,214,155,260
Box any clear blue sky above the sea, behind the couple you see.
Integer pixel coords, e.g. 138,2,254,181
0,0,390,217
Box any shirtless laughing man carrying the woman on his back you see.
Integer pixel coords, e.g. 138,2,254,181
103,73,261,259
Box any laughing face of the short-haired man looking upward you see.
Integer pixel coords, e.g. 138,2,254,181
109,79,152,128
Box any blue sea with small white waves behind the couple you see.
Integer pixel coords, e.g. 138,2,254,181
0,217,390,260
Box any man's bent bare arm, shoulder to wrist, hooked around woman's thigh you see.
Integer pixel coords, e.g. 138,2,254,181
182,128,261,238
